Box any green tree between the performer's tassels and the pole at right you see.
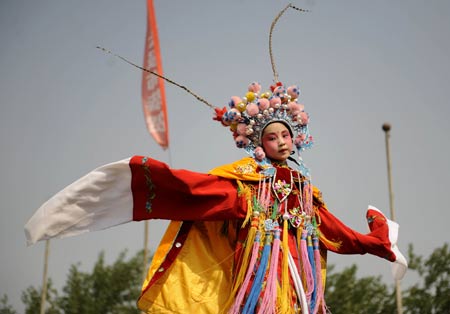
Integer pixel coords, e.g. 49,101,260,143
325,265,395,314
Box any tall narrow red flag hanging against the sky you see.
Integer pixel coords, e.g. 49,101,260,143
142,0,169,149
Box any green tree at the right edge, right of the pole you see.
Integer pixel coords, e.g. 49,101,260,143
403,243,450,314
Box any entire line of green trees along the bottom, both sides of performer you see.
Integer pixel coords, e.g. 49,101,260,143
0,243,450,314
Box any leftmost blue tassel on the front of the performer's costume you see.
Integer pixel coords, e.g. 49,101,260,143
242,233,271,314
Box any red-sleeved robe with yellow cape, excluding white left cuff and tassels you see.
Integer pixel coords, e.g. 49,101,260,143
130,156,399,313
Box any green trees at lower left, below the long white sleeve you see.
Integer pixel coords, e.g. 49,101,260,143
22,252,147,314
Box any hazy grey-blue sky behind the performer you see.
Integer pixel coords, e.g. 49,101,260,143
0,0,450,311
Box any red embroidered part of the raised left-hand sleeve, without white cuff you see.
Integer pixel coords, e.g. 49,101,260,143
130,156,246,220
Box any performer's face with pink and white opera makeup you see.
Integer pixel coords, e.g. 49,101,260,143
262,122,293,161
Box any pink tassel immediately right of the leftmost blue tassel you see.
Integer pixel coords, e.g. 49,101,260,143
258,229,281,314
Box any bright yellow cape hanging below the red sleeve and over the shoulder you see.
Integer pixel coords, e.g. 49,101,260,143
138,158,326,313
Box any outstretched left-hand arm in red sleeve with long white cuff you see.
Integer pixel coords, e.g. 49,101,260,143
25,157,245,245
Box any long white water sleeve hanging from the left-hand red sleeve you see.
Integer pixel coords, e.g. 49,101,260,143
25,158,133,245
